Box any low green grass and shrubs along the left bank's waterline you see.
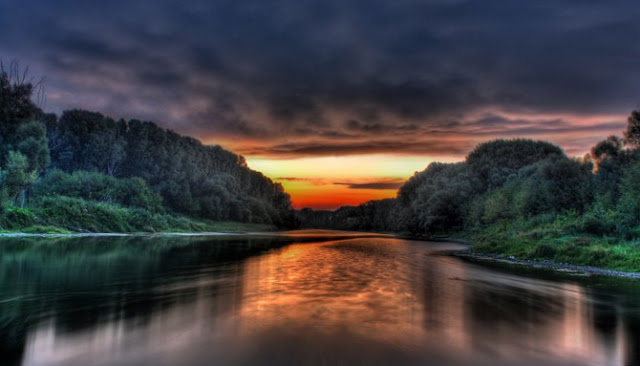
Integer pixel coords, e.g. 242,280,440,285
0,196,274,234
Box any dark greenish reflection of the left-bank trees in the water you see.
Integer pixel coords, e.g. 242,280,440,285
0,237,289,364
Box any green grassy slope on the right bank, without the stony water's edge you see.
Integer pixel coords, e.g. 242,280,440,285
462,214,640,272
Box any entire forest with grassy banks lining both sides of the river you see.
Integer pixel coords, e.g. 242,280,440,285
6,60,640,270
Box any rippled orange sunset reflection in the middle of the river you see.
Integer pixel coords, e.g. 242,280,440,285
240,239,438,348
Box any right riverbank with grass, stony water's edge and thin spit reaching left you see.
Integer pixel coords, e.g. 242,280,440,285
401,223,640,278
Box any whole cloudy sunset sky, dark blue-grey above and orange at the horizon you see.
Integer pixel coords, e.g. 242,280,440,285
0,0,640,209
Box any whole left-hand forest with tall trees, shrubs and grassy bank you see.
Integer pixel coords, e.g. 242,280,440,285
0,64,294,232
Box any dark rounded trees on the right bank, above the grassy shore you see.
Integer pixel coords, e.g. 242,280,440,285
297,111,640,239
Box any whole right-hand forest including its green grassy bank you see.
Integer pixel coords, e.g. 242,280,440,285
297,111,640,271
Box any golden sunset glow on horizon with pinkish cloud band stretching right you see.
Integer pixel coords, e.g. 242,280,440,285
220,110,625,209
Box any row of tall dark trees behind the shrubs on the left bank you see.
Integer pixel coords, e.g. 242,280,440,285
47,110,292,226
